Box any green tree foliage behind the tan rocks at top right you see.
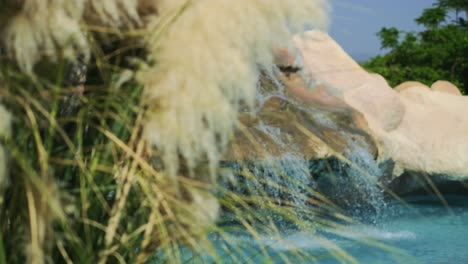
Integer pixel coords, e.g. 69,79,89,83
363,0,468,94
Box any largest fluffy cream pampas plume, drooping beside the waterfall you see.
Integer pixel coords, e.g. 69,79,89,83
140,0,327,179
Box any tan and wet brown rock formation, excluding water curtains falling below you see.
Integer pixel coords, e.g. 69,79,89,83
226,31,468,196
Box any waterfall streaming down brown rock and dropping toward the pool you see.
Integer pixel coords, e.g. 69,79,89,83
224,69,386,222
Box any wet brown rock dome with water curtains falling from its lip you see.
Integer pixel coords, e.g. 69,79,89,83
222,73,383,214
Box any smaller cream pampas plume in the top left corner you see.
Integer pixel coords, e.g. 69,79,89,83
1,0,88,73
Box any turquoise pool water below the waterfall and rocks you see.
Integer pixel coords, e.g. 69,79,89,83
207,196,468,264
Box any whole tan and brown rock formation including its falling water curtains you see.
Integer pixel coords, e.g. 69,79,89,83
224,31,468,206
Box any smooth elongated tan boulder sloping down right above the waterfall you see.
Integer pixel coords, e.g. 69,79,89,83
294,30,405,131
